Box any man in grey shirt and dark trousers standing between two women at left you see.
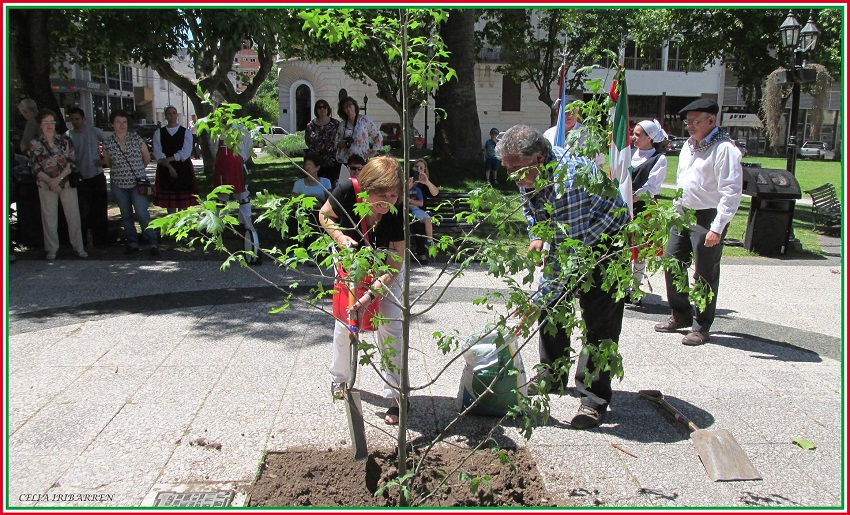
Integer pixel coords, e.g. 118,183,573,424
68,107,109,247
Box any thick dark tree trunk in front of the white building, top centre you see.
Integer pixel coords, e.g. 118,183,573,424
434,10,483,161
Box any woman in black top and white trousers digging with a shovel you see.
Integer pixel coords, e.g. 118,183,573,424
319,156,405,424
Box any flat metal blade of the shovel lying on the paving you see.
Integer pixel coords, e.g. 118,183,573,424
691,429,762,481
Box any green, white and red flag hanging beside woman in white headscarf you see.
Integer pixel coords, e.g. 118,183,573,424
609,67,633,215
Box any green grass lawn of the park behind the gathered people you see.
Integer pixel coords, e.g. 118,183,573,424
182,151,843,257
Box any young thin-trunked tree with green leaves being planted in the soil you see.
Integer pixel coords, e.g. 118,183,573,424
154,10,704,504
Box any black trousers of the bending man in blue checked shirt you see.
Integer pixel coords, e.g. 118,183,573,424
539,264,626,412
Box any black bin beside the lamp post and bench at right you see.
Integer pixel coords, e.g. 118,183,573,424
743,167,802,256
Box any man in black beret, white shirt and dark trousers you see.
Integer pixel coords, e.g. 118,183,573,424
655,98,743,345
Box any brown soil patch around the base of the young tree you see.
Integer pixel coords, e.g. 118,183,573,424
249,446,554,506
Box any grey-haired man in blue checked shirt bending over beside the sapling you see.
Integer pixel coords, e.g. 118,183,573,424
496,125,629,429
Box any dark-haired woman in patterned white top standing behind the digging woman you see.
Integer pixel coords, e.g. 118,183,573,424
336,97,384,183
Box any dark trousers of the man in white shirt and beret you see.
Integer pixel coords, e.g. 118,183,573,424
664,209,729,332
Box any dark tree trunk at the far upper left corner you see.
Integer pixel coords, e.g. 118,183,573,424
9,9,68,133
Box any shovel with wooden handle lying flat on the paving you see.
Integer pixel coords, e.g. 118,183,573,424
638,390,761,481
